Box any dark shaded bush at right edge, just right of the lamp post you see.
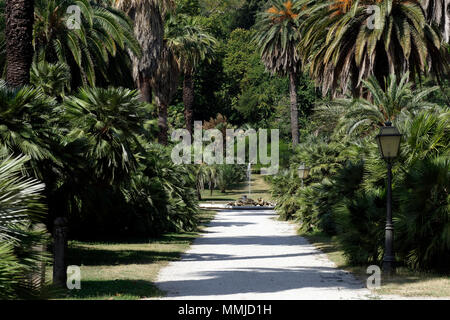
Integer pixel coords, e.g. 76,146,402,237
395,156,450,271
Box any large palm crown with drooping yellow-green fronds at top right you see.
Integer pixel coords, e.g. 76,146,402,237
299,0,448,96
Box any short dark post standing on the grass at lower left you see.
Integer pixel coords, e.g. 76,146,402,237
53,217,67,287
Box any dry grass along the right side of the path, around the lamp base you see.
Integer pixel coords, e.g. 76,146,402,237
300,233,450,297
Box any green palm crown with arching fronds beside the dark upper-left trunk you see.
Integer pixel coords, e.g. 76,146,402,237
34,0,140,86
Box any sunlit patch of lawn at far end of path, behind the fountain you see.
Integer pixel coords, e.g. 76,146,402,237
202,174,272,202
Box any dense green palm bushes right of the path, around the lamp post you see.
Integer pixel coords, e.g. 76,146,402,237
271,77,450,271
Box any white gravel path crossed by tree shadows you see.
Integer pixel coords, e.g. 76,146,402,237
156,210,374,300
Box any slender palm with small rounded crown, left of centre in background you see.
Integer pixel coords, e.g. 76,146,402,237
164,14,216,134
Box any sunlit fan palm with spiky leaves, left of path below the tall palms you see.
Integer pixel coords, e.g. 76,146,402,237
64,88,145,184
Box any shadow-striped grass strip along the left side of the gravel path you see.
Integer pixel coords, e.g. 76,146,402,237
47,210,214,300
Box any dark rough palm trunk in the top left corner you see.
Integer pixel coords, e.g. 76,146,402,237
5,0,34,87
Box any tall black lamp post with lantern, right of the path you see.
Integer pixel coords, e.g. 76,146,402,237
375,121,402,275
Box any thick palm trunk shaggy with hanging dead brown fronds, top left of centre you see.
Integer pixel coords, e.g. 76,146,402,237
114,0,173,102
